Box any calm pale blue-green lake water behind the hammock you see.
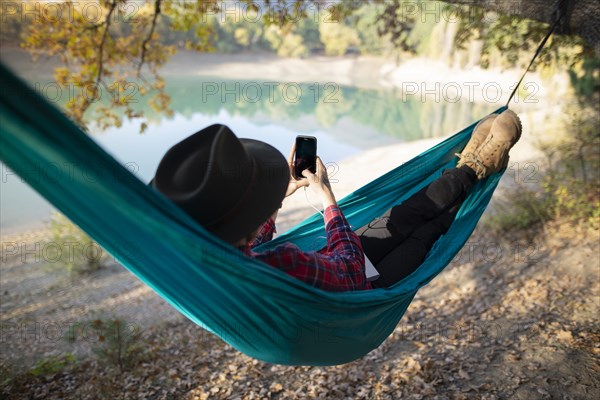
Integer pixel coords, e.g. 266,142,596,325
0,67,498,234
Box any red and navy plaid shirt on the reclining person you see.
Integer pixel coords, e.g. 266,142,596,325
243,206,371,292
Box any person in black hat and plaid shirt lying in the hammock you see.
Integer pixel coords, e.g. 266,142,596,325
152,110,521,291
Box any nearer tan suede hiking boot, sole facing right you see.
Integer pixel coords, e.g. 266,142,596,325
465,110,521,179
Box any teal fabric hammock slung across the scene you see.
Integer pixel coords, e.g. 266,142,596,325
0,65,505,365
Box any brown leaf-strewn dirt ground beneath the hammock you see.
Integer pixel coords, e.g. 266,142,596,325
0,208,600,399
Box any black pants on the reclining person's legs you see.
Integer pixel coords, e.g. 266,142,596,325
356,166,477,287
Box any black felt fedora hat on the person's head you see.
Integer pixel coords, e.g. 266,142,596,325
150,124,290,243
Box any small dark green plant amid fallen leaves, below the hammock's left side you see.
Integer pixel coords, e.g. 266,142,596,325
68,318,144,373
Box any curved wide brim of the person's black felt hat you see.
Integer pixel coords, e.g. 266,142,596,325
207,139,290,243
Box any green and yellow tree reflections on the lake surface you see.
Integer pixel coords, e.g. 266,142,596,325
85,76,500,144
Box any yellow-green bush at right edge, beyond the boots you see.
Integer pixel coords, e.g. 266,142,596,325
484,108,600,233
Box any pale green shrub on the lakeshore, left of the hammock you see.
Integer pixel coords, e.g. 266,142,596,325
45,213,108,275
